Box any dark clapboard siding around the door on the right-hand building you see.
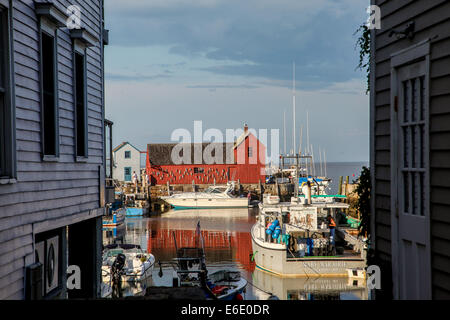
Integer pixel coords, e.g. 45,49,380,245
371,0,450,298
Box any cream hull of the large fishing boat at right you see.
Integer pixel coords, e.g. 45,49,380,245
251,224,366,277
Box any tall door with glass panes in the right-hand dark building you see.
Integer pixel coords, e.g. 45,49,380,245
392,45,431,299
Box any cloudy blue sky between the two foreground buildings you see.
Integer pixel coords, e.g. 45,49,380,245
105,0,369,162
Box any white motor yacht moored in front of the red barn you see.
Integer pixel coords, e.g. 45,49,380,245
161,182,248,210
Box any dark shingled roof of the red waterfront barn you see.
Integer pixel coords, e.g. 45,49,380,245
147,142,234,166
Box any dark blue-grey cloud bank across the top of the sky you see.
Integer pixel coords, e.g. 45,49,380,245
105,0,368,83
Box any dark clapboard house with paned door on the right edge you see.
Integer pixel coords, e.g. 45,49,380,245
370,0,450,299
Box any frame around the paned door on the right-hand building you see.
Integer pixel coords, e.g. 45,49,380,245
390,39,432,299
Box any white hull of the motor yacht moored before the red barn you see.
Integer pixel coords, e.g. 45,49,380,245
164,198,248,210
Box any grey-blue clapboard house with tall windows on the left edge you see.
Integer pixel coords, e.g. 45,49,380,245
0,0,107,299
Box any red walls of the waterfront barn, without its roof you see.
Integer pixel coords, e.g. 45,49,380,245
146,134,266,185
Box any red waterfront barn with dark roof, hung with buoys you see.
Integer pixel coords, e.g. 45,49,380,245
146,126,266,185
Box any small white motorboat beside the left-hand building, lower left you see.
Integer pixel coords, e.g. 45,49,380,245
102,243,155,283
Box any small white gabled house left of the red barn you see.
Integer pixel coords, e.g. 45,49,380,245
113,142,141,182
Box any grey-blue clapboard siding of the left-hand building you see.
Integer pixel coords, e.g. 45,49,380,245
0,0,104,299
